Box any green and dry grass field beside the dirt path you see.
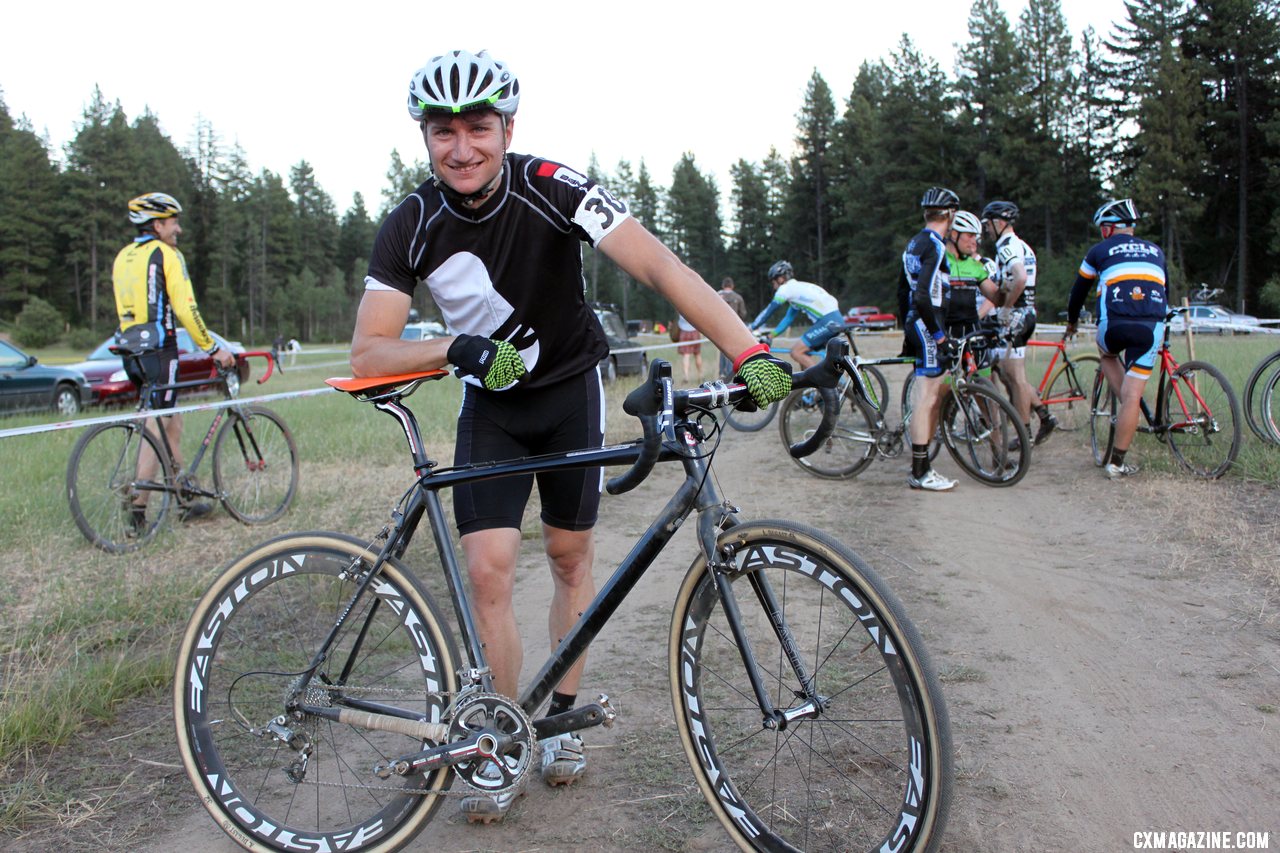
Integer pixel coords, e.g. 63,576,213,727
0,327,1280,838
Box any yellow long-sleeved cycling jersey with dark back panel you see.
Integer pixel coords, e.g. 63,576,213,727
111,234,216,352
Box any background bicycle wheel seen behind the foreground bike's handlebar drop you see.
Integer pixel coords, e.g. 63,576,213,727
778,387,879,480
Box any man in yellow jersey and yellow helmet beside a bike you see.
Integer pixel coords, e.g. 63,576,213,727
111,192,236,524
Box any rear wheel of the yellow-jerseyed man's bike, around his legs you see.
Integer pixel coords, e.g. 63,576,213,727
67,420,173,553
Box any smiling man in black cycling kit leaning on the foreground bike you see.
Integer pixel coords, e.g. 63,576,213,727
351,51,791,821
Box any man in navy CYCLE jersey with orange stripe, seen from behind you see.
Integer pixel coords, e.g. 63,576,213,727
1066,199,1169,479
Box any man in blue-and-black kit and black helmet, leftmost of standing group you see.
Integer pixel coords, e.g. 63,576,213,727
902,187,960,492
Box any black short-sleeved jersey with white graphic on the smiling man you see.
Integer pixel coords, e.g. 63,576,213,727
365,154,630,389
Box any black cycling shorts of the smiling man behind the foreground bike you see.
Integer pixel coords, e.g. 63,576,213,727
453,370,604,534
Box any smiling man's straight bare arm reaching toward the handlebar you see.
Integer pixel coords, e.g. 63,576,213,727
600,219,756,359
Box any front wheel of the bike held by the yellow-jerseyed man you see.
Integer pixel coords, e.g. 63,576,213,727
214,406,298,524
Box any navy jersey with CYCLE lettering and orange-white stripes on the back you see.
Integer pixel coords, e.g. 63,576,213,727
1068,234,1169,320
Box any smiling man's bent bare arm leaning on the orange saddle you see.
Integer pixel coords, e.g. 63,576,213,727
351,291,453,377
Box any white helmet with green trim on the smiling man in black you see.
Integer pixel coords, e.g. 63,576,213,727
408,50,520,122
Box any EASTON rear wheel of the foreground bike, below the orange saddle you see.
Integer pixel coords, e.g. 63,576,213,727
173,533,457,850
